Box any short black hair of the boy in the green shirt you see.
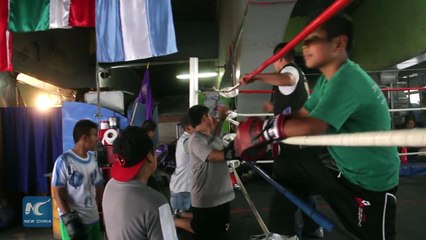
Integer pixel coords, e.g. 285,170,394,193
311,13,353,53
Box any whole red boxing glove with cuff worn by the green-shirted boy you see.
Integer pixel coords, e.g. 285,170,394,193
234,115,286,161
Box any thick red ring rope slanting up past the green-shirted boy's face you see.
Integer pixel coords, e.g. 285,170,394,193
244,0,351,81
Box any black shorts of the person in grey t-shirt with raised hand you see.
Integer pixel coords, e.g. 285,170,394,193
191,202,231,240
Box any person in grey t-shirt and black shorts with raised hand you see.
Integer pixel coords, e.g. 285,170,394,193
188,105,235,240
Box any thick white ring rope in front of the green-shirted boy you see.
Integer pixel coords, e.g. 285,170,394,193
282,129,426,147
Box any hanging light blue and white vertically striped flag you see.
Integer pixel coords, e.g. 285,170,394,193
96,0,177,62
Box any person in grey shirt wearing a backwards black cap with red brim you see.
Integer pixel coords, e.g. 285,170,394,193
102,126,178,240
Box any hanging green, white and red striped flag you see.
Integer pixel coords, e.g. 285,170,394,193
9,0,95,32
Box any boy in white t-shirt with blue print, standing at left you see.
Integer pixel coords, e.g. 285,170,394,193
52,120,104,240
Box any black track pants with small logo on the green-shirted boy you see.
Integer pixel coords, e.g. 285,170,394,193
275,147,397,240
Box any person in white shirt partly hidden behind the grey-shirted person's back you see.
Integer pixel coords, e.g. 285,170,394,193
170,115,194,216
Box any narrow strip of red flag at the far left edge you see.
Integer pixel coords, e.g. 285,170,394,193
0,0,12,72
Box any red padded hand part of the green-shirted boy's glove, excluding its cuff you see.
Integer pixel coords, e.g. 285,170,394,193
234,117,268,161
